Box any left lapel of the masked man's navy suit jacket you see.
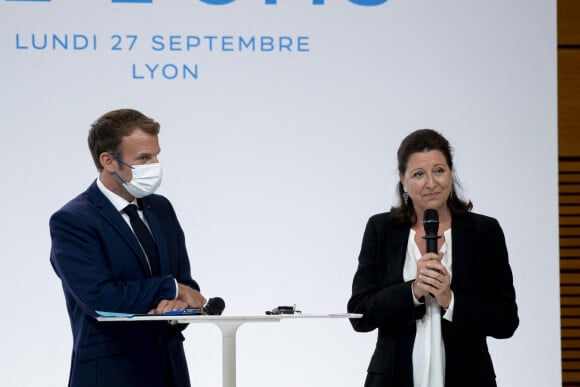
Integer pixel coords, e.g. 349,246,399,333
87,182,151,277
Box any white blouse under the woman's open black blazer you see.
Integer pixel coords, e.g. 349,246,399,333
403,228,452,387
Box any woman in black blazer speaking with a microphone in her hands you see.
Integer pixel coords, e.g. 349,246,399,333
348,129,519,387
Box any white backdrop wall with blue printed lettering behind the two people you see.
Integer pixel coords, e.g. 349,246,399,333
0,0,561,387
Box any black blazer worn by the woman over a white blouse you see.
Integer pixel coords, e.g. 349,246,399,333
348,213,519,387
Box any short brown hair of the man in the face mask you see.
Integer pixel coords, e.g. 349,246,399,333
88,109,159,172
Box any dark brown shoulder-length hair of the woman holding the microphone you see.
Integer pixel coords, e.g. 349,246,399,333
391,129,473,225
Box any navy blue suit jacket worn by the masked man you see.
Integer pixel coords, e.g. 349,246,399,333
50,182,199,387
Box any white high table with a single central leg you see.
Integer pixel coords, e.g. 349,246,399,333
97,313,362,387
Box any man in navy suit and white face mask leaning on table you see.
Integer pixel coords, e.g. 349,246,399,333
50,109,206,387
